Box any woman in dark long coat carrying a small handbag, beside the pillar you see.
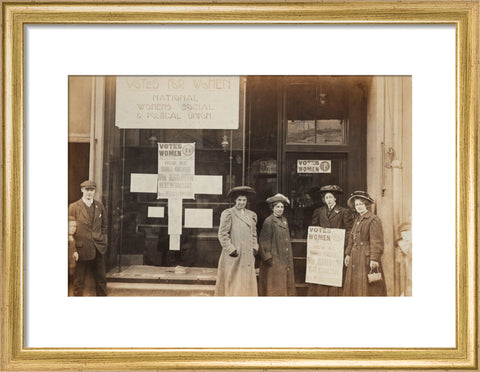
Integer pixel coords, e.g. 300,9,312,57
343,191,387,296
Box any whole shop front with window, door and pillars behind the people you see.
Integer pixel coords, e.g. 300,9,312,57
69,76,411,295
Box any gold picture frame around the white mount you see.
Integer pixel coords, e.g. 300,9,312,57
1,1,479,371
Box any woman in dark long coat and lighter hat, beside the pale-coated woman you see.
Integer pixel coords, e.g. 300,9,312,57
259,194,296,296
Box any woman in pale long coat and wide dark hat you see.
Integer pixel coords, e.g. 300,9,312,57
215,186,258,296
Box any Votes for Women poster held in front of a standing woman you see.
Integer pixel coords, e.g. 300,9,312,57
305,226,345,287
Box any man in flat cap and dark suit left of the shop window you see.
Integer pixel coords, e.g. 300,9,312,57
68,180,107,296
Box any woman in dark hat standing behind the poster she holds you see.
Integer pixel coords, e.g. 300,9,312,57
308,185,353,296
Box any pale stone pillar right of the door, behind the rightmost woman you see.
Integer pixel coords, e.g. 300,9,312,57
367,76,412,295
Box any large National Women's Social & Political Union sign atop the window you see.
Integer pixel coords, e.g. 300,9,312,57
115,76,240,129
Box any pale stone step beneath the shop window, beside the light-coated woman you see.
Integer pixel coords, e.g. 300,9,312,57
107,282,215,296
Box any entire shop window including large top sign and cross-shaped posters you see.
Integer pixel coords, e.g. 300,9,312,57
104,77,251,267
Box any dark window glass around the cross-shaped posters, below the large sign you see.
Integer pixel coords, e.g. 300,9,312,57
115,126,245,266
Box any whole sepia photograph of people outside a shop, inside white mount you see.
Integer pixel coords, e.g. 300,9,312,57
65,75,414,296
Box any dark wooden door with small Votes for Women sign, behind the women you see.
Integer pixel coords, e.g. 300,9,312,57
277,76,369,295
